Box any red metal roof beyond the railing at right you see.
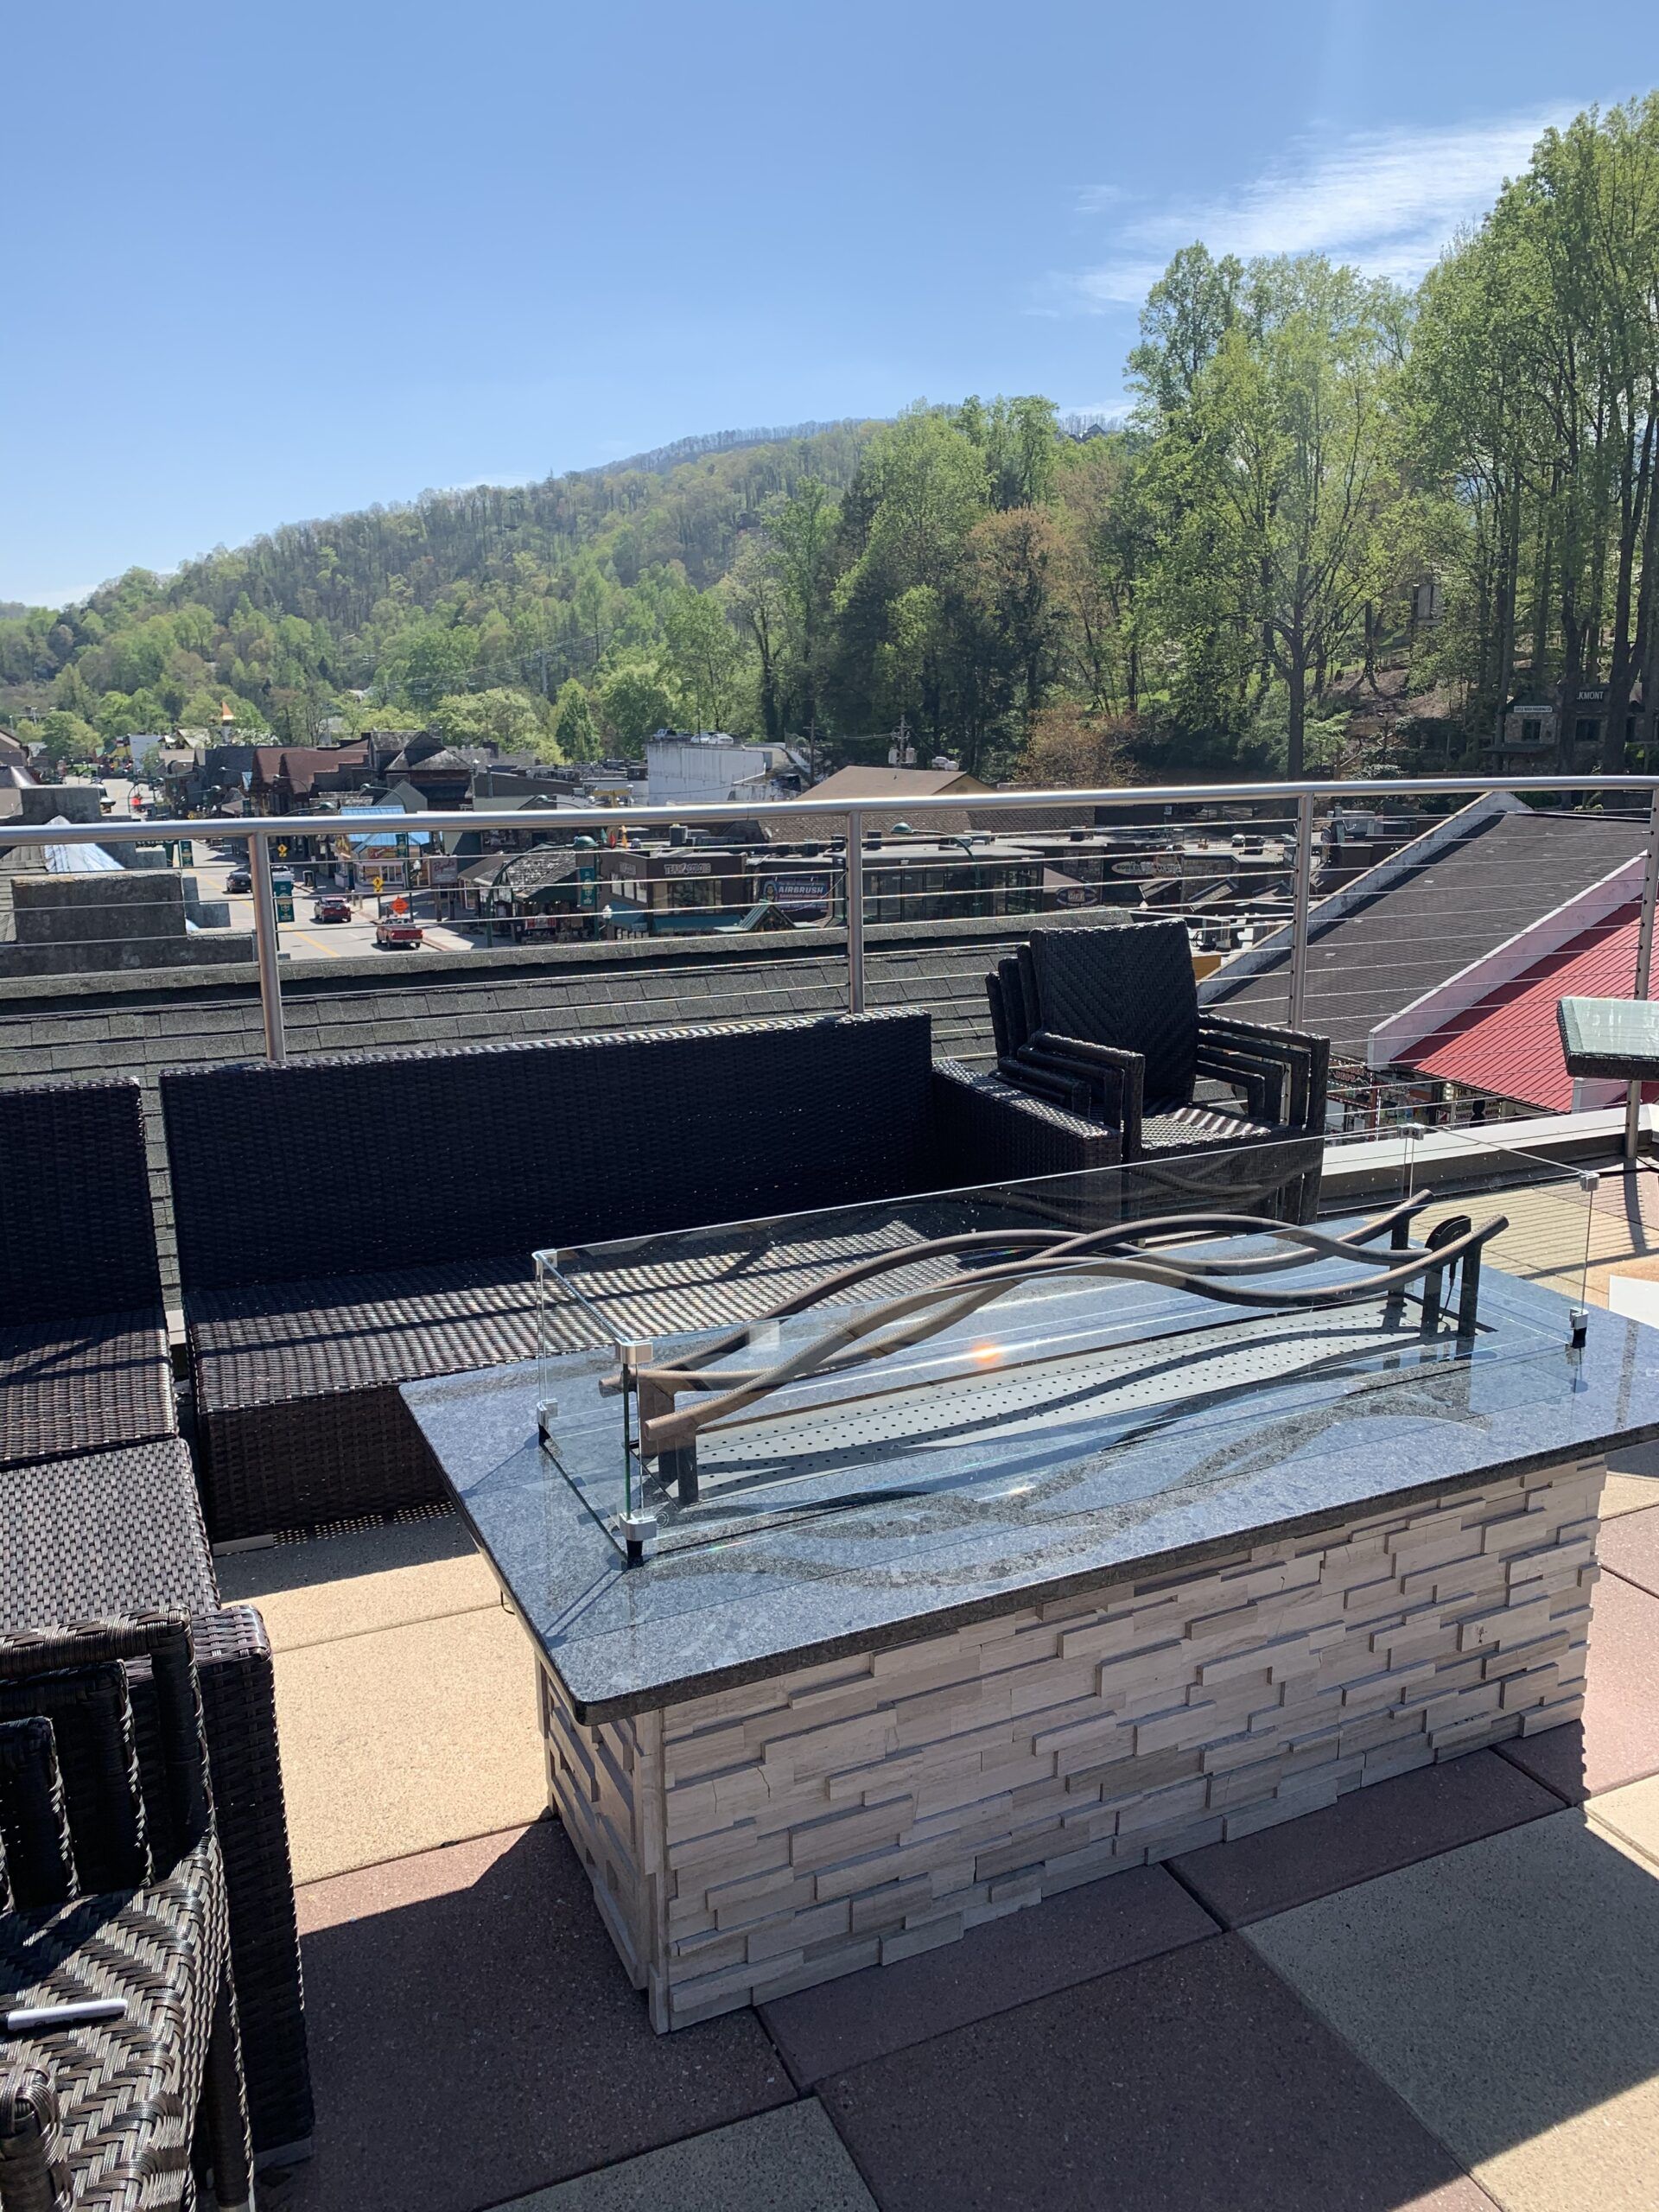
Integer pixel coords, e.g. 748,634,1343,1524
1407,907,1655,1113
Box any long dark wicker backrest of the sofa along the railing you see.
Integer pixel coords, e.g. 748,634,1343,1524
162,1011,931,1292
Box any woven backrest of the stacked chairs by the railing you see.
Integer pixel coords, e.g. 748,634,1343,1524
1031,923,1199,1113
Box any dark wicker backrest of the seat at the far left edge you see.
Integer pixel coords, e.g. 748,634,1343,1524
0,1079,162,1327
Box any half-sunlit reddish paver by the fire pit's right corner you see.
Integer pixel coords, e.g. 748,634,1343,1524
1497,1575,1659,1805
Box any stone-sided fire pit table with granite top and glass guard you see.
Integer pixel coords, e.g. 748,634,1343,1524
403,1146,1659,2029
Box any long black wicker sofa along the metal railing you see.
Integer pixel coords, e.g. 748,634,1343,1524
162,1011,1117,1541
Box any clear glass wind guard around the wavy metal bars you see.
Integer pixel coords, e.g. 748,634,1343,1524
536,1137,1581,1557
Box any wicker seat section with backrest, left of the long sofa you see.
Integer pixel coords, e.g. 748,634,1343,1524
0,1082,179,1469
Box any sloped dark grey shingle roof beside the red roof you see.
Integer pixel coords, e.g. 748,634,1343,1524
1210,814,1646,1059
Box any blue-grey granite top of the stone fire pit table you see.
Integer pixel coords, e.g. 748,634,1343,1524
403,1268,1659,1721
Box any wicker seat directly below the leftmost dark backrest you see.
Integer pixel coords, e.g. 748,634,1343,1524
0,1305,179,1469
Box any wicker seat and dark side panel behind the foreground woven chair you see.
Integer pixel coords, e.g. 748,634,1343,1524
0,1438,312,2165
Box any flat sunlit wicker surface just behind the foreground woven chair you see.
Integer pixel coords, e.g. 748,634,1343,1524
0,1435,219,1630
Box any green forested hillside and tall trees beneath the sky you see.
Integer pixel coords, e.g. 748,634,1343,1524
0,95,1659,781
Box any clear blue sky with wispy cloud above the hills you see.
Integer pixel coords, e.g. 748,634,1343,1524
0,0,1659,604
